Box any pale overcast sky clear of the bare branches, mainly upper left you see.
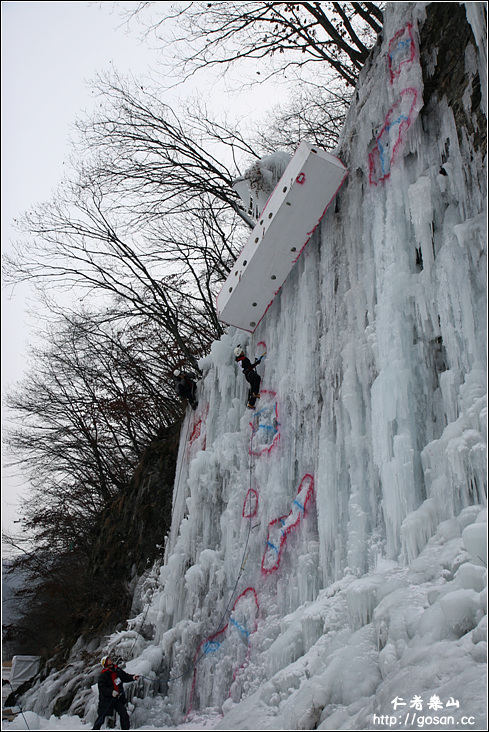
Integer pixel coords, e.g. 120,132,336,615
1,2,278,548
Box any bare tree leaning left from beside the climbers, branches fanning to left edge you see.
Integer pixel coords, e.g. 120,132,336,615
4,187,215,368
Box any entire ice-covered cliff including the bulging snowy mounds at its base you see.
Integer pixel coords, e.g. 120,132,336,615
14,3,487,730
